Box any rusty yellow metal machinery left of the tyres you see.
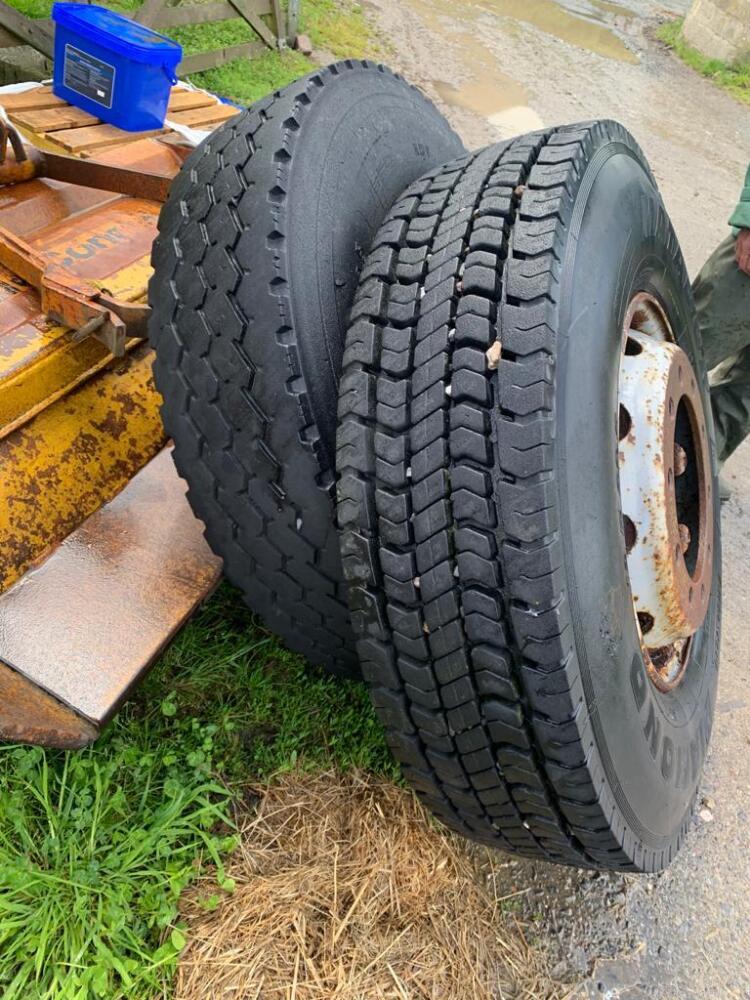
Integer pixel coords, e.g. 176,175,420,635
0,86,236,746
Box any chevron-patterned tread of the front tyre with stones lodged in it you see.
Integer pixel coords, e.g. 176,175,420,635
338,122,680,870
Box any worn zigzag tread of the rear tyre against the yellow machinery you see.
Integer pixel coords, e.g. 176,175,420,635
150,60,462,676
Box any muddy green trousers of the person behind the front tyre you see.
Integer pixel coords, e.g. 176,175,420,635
693,235,750,464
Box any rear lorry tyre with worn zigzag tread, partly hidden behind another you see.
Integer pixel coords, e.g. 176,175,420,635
149,61,463,674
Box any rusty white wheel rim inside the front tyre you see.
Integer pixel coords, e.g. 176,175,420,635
617,292,713,692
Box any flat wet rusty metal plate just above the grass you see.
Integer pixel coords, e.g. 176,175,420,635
0,449,221,742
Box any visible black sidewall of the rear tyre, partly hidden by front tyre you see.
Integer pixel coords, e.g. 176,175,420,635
285,67,464,466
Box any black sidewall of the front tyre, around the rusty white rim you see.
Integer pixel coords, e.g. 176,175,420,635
556,142,721,867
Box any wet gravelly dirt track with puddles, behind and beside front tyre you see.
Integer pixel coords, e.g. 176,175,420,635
356,0,750,1000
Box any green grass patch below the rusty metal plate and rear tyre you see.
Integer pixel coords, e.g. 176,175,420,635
0,587,395,1000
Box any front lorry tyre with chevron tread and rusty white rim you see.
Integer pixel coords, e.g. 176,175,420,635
337,121,720,871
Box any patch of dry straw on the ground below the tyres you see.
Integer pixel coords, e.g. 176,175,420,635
176,774,557,1000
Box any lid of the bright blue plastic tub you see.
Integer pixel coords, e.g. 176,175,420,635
52,2,182,65
